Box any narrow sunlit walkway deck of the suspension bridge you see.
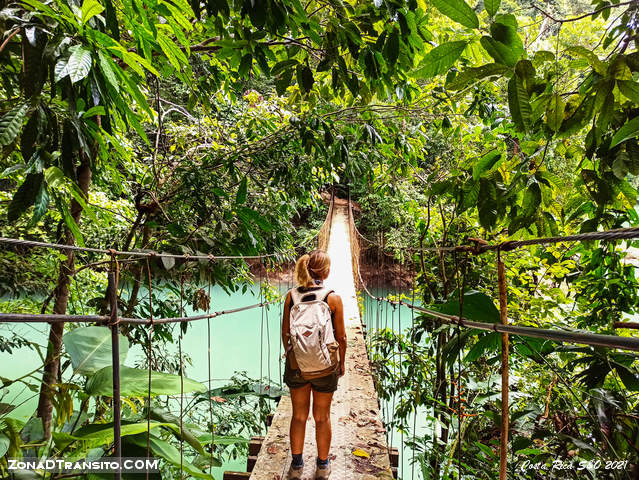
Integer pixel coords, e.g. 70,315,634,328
250,206,393,480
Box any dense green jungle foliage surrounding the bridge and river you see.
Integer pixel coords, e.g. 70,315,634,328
0,0,639,478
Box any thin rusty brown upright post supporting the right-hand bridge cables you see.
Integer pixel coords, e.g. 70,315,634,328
497,250,509,480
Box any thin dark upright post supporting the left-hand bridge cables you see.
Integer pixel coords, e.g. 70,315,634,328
108,272,122,480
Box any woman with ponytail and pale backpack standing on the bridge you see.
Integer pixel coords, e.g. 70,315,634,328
282,250,346,480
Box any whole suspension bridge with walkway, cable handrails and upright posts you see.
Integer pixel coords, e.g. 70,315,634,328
0,191,639,480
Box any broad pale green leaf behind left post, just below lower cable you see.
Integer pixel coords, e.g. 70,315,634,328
62,326,129,375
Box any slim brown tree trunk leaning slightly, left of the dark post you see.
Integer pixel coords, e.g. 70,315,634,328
37,155,91,439
